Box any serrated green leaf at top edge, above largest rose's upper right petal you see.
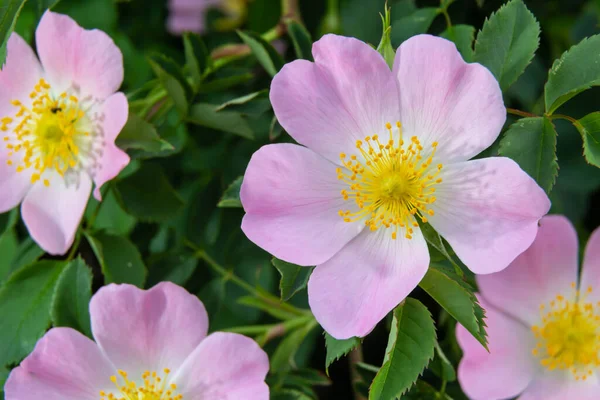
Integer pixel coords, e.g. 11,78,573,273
473,0,540,91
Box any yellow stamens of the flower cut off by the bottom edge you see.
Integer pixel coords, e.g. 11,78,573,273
100,368,183,400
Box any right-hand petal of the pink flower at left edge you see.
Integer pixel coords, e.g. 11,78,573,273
94,92,130,201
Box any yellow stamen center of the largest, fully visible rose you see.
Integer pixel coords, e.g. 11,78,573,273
336,122,442,239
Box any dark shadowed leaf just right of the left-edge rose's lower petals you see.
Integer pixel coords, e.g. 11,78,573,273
115,162,184,222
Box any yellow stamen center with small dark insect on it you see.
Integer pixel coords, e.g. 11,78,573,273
0,79,96,186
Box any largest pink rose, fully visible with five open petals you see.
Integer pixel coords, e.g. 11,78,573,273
241,35,550,339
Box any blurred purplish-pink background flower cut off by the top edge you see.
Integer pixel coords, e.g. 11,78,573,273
167,0,247,35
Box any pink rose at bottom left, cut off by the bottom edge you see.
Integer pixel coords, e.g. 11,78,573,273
4,282,269,400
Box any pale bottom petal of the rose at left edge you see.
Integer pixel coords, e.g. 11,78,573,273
21,172,92,255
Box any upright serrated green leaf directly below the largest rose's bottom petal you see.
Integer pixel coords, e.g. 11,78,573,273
369,298,436,400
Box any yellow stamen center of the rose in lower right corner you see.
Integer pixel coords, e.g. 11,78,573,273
531,283,600,380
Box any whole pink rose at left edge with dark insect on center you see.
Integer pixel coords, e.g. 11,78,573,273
0,12,129,254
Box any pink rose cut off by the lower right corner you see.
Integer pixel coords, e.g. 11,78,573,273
456,216,600,400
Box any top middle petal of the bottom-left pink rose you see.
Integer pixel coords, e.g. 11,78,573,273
90,282,208,379
